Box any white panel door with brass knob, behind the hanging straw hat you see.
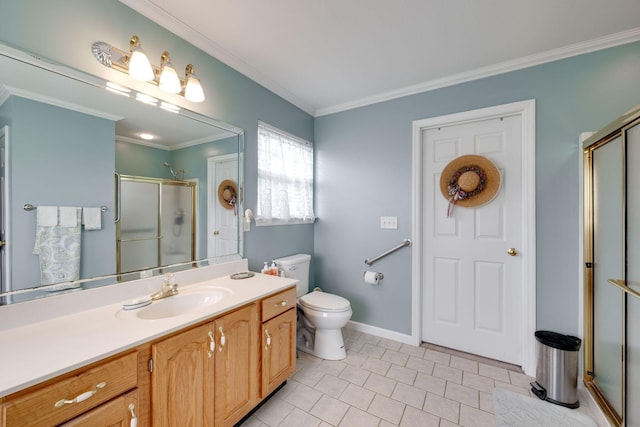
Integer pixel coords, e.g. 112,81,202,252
422,116,526,364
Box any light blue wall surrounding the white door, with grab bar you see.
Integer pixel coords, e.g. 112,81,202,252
315,43,640,334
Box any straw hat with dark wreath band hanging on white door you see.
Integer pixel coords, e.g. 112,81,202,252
440,154,502,217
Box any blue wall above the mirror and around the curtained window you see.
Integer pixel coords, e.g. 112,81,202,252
0,0,313,276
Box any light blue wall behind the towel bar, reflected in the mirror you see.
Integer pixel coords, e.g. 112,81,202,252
8,97,115,290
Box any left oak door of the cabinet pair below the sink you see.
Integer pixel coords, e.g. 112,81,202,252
151,322,215,427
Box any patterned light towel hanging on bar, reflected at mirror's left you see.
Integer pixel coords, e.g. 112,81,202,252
33,206,81,285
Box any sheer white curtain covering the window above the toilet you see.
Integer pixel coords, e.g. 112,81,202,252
255,122,315,225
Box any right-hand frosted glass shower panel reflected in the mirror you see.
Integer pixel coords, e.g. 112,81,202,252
161,183,195,265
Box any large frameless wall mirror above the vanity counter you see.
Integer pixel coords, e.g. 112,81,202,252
0,46,243,304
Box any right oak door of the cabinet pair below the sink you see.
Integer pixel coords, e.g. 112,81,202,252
214,304,260,427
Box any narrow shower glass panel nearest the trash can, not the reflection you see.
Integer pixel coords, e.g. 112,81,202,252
593,137,624,417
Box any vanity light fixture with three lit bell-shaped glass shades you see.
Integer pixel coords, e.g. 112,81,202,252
91,36,205,102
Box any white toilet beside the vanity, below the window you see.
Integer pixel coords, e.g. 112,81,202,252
275,254,352,360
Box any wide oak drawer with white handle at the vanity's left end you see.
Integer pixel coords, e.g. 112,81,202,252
2,352,138,426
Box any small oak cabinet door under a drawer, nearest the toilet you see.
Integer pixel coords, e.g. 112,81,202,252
261,308,296,399
